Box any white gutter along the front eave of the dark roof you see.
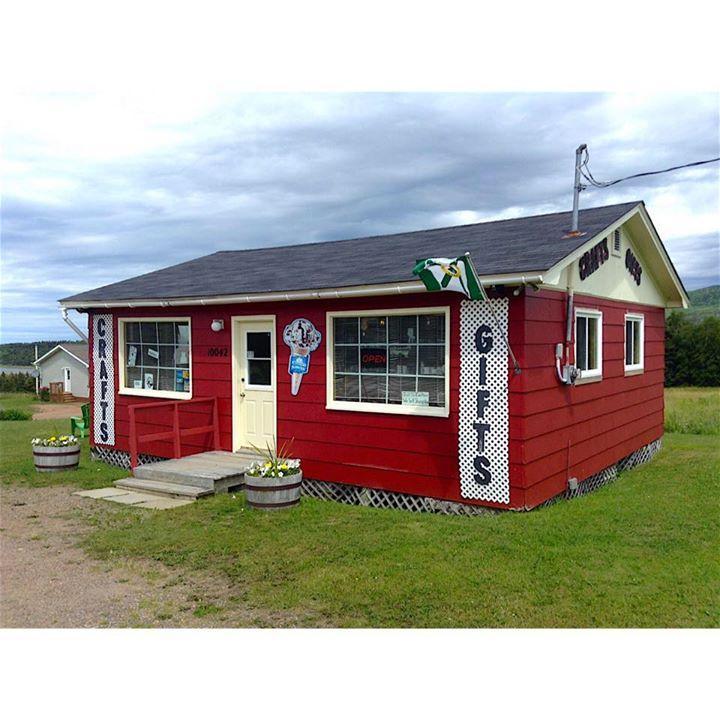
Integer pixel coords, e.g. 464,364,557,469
60,274,543,310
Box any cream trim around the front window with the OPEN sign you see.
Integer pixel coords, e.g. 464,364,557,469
325,305,450,417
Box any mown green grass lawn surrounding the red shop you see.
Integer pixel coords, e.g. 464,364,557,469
0,391,720,627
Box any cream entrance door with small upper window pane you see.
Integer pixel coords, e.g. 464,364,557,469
235,320,275,448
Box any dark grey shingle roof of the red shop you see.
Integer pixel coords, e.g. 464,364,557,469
60,202,639,306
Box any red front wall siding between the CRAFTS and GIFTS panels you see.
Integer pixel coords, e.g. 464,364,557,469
94,293,484,502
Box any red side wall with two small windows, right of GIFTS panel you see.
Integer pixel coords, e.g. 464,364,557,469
510,291,665,507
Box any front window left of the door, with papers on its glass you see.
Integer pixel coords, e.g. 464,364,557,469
118,318,192,399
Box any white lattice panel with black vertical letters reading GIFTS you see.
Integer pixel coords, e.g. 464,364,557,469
458,298,510,504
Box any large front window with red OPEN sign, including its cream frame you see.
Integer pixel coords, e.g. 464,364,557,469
328,308,449,416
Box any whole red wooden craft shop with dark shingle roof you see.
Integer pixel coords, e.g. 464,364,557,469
61,202,687,511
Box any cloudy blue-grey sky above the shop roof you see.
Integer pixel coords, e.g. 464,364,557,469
1,93,720,342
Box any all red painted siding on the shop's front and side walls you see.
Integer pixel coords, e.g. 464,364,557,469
90,284,664,508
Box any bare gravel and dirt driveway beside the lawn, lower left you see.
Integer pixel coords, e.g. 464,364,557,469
0,486,306,627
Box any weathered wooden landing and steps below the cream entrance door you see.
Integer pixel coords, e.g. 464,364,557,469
114,450,259,498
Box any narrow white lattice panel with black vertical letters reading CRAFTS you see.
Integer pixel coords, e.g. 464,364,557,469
92,315,115,445
